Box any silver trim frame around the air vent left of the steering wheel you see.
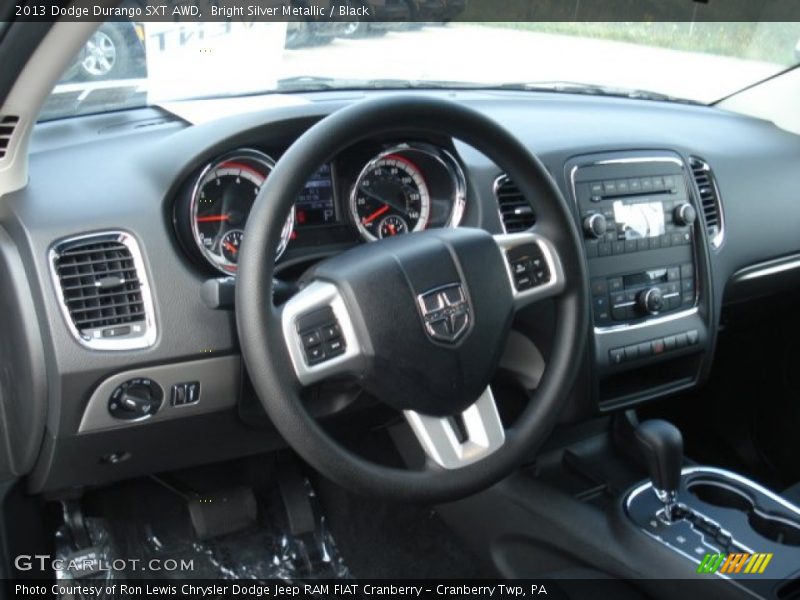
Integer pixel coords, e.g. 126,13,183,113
47,230,158,351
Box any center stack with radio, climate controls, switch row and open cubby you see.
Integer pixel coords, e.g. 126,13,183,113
567,152,710,409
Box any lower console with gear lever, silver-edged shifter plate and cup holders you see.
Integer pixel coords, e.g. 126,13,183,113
624,420,800,599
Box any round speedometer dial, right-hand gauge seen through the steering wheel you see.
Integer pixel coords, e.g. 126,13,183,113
350,153,431,240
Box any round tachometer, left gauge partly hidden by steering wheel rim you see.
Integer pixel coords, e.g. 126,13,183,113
191,149,294,274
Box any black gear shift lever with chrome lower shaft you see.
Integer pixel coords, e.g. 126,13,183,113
634,419,683,521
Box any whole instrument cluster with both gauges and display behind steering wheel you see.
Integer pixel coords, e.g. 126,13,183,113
173,142,466,275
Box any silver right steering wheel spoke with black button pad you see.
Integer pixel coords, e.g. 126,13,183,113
494,231,566,310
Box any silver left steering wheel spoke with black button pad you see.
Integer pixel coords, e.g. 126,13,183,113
281,281,363,385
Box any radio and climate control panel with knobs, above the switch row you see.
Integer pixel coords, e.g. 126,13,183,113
572,158,697,328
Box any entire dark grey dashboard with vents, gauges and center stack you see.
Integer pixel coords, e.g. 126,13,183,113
0,91,800,491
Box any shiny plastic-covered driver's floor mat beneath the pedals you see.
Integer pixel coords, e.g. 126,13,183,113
55,480,350,581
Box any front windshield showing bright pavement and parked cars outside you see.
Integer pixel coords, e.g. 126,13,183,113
40,21,800,120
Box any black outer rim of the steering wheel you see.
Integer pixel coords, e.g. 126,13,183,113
236,95,588,502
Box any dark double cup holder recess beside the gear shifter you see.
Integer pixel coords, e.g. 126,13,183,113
688,481,800,546
